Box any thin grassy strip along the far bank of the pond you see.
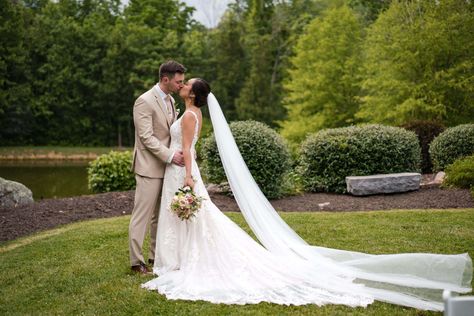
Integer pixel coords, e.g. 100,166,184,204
0,146,132,159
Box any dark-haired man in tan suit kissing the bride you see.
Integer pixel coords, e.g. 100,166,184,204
129,61,186,274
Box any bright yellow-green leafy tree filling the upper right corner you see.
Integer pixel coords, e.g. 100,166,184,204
357,0,474,126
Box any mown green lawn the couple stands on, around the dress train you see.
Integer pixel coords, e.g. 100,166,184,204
0,209,474,315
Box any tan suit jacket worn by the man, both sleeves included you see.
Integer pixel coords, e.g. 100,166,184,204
132,87,176,178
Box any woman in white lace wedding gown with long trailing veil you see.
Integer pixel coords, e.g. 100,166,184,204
142,79,472,311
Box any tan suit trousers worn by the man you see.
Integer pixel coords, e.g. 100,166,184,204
128,174,163,266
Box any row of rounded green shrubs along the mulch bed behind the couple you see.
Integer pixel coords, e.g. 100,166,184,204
89,121,474,198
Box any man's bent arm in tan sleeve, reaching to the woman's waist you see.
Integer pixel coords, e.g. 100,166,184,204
133,98,174,162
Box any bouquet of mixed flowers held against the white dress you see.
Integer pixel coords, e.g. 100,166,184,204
170,186,204,221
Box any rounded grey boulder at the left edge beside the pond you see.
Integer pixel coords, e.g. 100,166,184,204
0,178,34,208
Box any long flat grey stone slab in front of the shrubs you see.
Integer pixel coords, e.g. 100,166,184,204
346,173,421,195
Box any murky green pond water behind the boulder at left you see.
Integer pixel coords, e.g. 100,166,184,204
0,160,91,200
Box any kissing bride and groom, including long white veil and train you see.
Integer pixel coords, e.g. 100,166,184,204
129,61,472,311
